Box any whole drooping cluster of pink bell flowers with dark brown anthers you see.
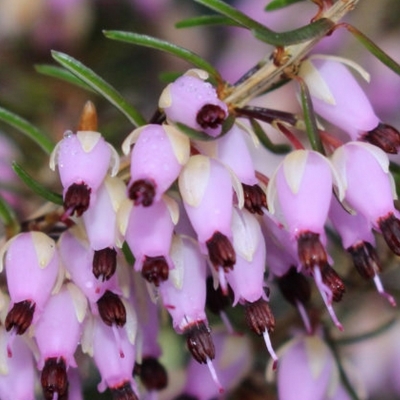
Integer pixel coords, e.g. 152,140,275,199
0,2,400,400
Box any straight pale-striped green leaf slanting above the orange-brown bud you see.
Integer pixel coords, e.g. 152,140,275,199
51,50,146,126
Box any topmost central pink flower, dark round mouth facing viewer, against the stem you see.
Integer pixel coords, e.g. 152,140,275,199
158,69,228,137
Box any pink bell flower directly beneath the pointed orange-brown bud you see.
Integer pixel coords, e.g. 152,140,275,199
50,131,119,216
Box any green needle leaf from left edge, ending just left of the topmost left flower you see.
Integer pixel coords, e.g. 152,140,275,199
0,107,54,154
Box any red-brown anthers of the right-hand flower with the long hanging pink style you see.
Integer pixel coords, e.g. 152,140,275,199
297,231,327,271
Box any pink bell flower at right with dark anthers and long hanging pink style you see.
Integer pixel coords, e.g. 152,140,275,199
267,150,343,329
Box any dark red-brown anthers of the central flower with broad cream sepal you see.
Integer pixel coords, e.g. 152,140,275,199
206,231,236,272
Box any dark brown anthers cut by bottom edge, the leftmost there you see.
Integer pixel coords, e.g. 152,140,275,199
40,357,68,400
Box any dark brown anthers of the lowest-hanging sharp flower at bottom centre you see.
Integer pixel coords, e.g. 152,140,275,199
184,321,215,364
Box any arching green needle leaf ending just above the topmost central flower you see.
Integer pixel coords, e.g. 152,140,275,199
104,31,220,80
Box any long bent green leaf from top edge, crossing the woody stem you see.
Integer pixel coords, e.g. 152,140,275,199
194,0,334,46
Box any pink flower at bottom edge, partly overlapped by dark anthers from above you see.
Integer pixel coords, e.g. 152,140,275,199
82,317,138,400
